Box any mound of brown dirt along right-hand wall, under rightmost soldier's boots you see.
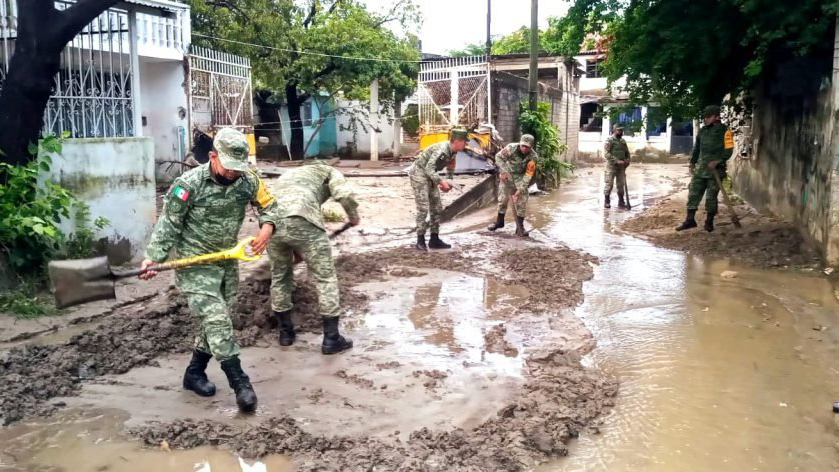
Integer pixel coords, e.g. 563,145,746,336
620,179,821,269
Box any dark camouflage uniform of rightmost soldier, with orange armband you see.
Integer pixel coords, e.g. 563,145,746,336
687,122,734,215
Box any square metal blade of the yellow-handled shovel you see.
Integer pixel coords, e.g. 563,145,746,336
49,257,116,308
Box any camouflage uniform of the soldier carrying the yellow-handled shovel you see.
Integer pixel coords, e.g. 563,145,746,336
145,136,274,361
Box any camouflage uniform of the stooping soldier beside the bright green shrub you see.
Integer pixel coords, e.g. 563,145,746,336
495,143,539,217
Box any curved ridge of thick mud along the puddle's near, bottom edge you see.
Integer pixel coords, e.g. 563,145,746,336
131,344,617,471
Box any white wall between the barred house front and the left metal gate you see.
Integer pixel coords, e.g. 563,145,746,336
140,59,189,183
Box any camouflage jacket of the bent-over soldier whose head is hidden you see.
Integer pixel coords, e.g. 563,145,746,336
276,163,358,230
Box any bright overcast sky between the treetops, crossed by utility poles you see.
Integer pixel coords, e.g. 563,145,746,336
364,0,569,54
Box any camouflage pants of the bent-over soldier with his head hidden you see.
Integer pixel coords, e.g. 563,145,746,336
268,216,339,316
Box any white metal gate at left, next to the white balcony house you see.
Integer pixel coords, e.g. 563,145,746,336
189,46,253,135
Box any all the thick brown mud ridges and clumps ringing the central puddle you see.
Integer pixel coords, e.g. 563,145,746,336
0,240,617,471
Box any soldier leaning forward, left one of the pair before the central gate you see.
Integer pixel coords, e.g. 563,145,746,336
408,125,467,251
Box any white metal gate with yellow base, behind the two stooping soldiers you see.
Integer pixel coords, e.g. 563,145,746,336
418,56,492,133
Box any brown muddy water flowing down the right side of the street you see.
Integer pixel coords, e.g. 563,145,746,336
532,166,839,472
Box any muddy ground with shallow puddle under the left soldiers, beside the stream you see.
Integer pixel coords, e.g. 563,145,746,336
0,171,617,471
